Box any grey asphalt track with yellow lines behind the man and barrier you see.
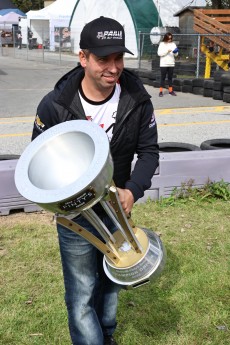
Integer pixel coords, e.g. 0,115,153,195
0,56,230,155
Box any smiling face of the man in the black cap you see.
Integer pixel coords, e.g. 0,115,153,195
79,51,124,90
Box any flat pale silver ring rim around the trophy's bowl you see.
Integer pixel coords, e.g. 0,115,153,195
15,120,110,204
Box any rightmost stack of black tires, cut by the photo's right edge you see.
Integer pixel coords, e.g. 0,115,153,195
212,70,230,103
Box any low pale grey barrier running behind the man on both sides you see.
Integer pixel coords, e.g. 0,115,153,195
0,149,230,216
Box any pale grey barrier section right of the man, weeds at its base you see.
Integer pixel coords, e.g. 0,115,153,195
138,149,230,203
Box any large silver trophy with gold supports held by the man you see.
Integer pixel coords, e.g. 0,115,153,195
15,120,166,288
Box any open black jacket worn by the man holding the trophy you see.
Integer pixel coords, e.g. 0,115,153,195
32,66,159,201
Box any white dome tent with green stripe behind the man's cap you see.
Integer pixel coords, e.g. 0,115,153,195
71,0,205,57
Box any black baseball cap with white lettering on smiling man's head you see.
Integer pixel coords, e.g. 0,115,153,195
80,17,133,56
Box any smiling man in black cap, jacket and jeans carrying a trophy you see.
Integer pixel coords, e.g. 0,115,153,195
32,17,159,345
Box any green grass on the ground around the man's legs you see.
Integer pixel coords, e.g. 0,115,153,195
0,183,230,345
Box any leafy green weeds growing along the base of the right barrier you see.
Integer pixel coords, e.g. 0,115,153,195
159,179,230,206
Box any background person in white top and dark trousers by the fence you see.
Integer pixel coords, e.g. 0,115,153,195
157,32,179,97
